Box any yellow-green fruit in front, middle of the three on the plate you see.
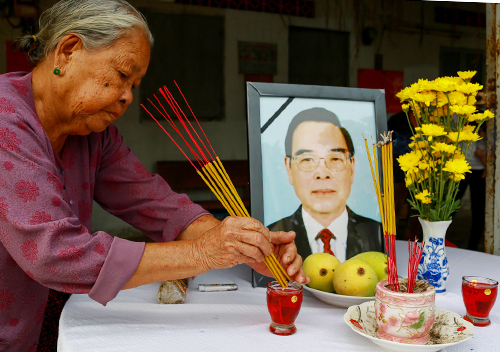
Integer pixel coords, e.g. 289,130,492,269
332,258,378,297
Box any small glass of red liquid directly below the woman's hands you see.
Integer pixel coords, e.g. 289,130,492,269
267,281,302,335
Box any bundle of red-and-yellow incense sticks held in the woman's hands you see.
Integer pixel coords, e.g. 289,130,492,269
141,81,292,287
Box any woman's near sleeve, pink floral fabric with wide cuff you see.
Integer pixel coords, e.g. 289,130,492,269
0,109,144,304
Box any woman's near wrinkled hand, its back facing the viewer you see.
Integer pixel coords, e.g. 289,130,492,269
193,216,273,270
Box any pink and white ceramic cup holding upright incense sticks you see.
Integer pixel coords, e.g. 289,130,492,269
375,279,436,345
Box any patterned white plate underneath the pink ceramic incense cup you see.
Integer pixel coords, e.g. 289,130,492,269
344,302,474,352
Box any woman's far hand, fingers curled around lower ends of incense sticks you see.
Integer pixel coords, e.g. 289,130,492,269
248,231,310,284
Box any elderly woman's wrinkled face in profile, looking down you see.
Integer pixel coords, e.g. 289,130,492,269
57,30,150,135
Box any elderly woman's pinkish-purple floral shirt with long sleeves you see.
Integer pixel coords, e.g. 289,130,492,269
0,73,207,351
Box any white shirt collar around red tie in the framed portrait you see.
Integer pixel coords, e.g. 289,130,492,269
302,208,349,262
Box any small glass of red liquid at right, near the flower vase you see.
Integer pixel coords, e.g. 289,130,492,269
462,276,498,326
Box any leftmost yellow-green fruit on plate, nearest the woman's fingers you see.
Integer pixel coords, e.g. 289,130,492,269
302,253,340,292
